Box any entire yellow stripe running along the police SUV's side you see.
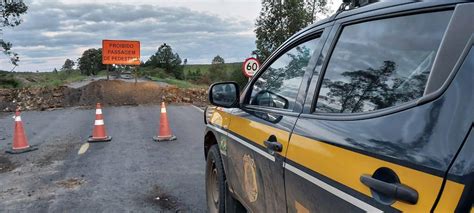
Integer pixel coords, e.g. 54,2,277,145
212,110,464,212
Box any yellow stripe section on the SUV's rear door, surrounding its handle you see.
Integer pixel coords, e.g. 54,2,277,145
287,135,462,212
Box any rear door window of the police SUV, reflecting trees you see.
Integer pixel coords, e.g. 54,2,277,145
316,11,451,113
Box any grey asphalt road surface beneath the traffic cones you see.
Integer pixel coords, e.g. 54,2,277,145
0,105,206,212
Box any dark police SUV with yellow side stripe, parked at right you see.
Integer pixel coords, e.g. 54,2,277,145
204,0,474,212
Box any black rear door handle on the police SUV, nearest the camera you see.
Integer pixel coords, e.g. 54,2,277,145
360,175,418,204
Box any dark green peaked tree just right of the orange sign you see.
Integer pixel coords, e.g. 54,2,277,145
145,43,184,79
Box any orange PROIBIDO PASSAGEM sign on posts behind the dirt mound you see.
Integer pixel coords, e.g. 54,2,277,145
102,40,140,82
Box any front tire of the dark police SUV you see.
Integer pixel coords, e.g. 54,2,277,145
206,145,227,213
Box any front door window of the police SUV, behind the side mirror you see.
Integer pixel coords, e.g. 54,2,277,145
250,38,319,110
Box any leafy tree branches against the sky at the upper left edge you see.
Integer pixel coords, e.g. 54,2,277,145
0,0,28,66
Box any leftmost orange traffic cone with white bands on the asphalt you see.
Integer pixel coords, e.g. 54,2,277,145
6,109,38,154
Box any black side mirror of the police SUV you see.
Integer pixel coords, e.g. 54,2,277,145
209,82,240,108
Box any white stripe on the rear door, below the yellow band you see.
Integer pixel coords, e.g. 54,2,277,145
283,163,383,212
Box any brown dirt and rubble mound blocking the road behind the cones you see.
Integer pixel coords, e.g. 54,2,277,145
0,80,207,111
